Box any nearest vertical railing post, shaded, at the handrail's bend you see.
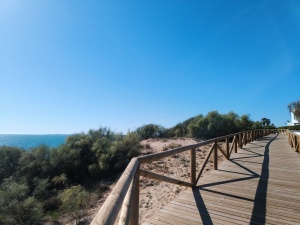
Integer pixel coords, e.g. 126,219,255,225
129,165,140,225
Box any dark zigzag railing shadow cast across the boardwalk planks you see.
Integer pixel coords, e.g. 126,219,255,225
193,136,277,225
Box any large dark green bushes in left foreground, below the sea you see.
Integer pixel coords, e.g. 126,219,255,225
0,128,141,225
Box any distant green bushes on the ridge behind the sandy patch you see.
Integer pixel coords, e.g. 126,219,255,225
136,111,275,139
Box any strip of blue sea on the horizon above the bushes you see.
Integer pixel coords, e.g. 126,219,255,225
0,134,70,150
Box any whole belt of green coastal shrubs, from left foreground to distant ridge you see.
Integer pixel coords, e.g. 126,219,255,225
0,111,275,225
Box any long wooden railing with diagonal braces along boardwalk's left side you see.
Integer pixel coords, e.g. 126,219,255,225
91,129,286,225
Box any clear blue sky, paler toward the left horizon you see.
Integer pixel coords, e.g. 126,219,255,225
0,0,300,134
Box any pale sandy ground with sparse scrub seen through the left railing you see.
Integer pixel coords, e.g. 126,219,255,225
84,138,224,224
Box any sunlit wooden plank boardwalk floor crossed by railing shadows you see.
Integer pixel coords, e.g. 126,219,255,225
143,134,300,225
